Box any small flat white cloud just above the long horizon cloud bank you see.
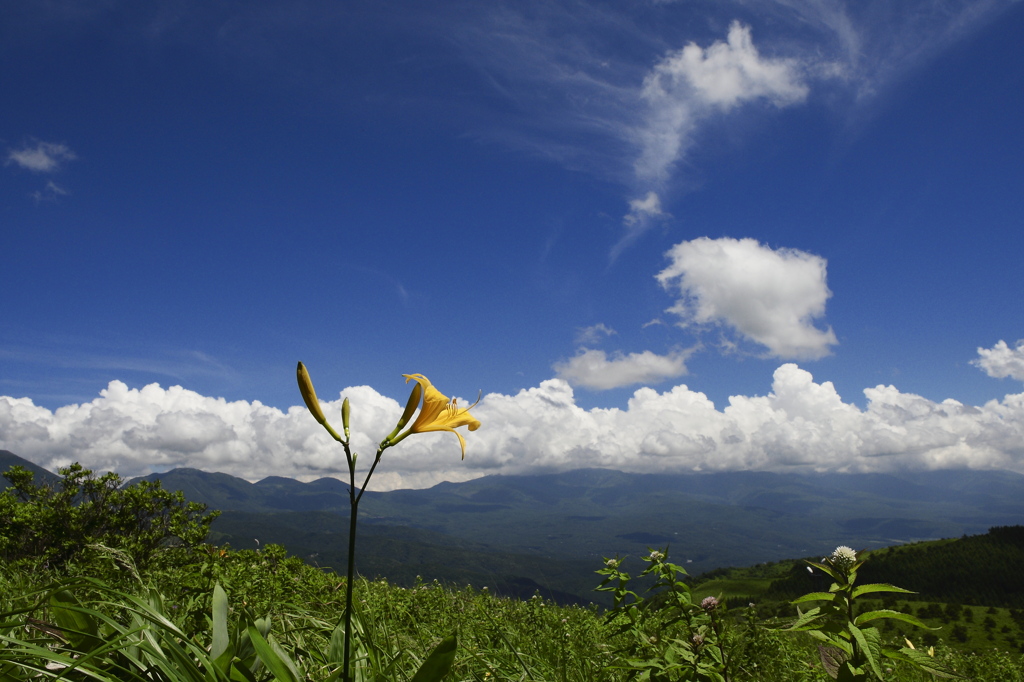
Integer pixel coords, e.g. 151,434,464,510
554,350,689,391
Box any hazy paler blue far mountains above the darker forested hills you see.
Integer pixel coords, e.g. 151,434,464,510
136,469,1024,570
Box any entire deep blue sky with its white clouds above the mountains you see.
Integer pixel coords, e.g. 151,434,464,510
0,0,1024,485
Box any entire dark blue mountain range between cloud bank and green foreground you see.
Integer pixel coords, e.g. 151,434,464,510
6,453,1024,601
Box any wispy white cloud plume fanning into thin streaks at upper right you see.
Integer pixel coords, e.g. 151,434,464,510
445,0,1015,254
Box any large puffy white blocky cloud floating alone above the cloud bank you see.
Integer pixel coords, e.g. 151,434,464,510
656,237,839,358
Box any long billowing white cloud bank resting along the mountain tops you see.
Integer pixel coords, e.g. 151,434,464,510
0,341,1024,489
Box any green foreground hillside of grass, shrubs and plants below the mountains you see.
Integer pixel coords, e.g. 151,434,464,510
0,458,1024,682
